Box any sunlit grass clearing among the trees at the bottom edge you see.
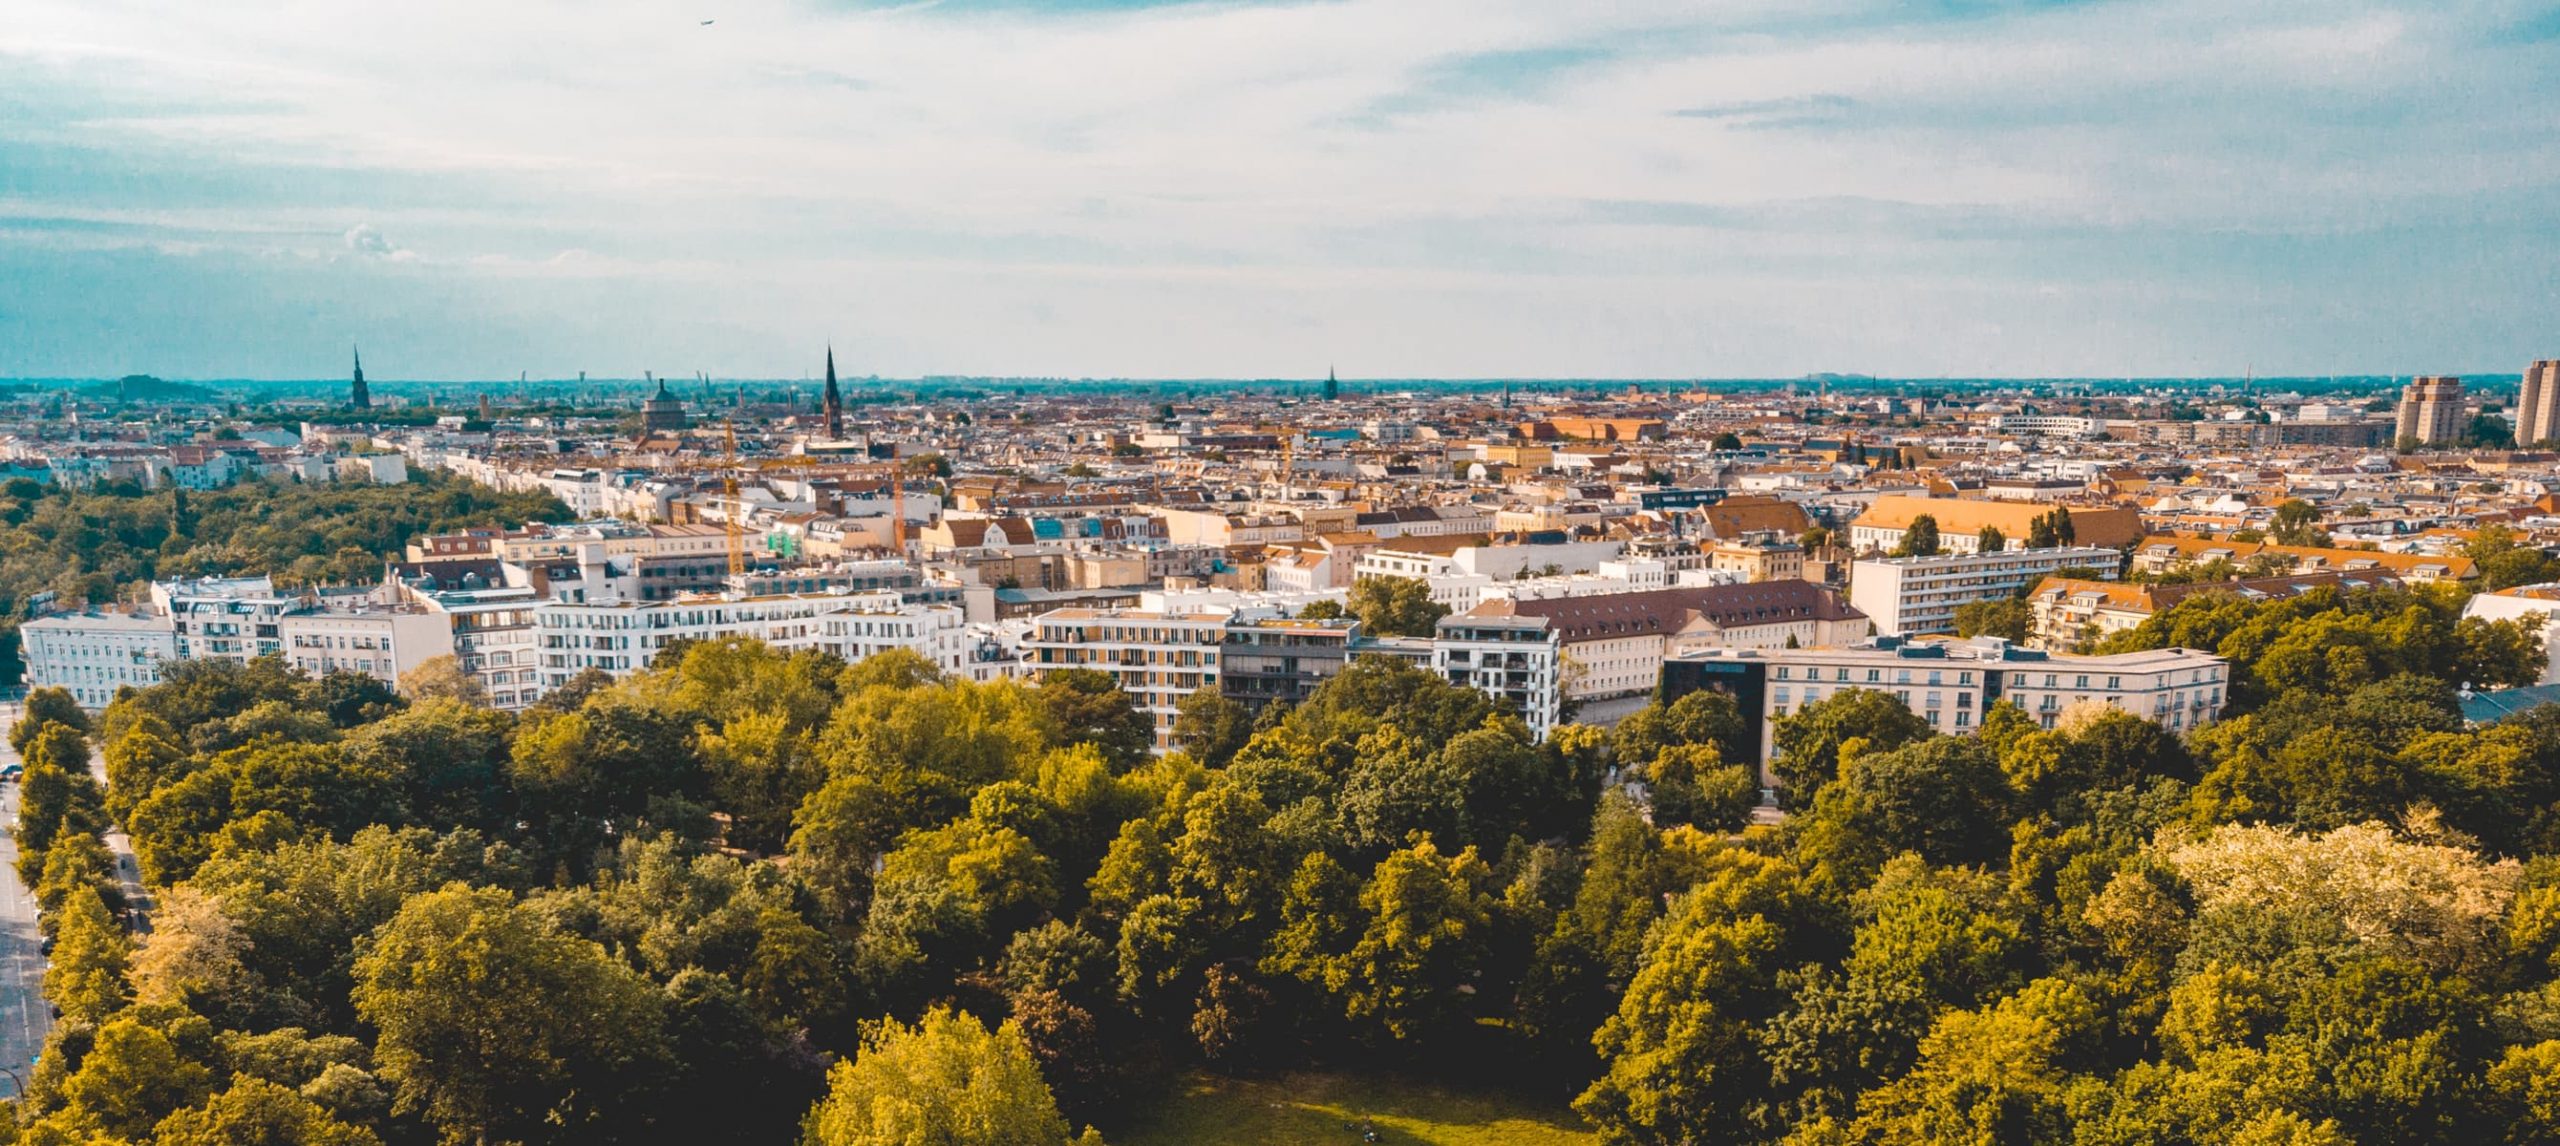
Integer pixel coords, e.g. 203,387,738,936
1108,1074,1600,1146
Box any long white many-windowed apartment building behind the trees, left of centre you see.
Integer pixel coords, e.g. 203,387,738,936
532,593,970,691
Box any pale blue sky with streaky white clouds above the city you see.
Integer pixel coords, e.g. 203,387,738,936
0,0,2560,379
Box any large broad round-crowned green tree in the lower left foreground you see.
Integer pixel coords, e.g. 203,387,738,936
353,885,666,1141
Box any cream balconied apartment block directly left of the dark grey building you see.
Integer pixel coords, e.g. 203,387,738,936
1024,609,1236,752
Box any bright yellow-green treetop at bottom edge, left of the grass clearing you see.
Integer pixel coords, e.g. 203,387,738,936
801,1008,1070,1146
